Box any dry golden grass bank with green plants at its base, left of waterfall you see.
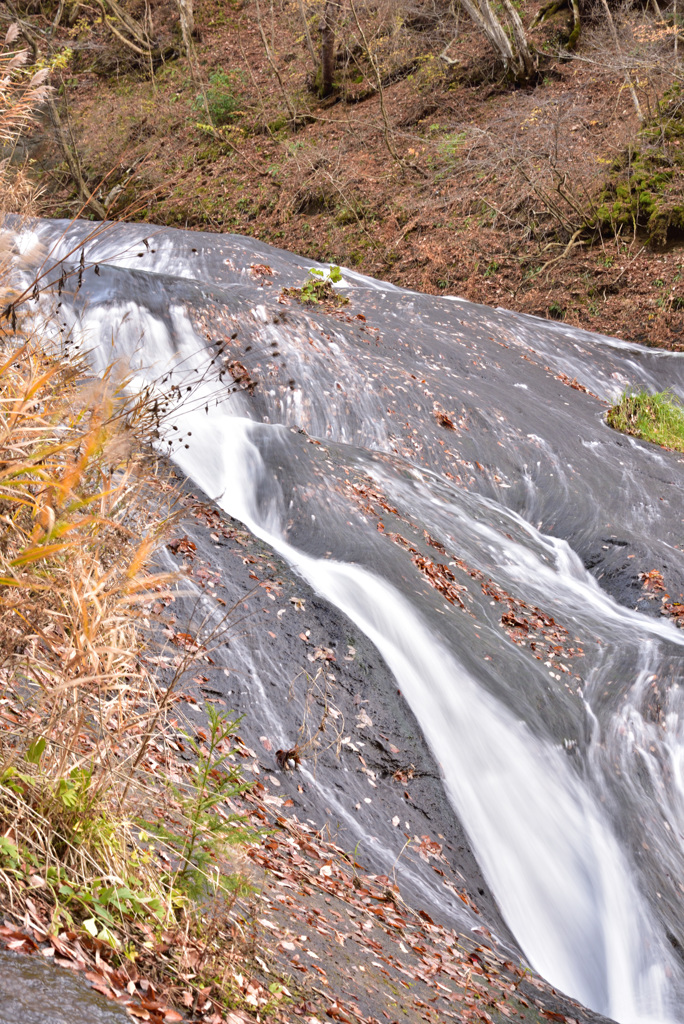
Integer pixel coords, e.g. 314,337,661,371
0,274,270,1020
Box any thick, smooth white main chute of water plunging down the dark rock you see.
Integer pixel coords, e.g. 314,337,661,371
166,411,676,1024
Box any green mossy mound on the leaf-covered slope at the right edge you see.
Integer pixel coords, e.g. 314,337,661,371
594,86,684,246
